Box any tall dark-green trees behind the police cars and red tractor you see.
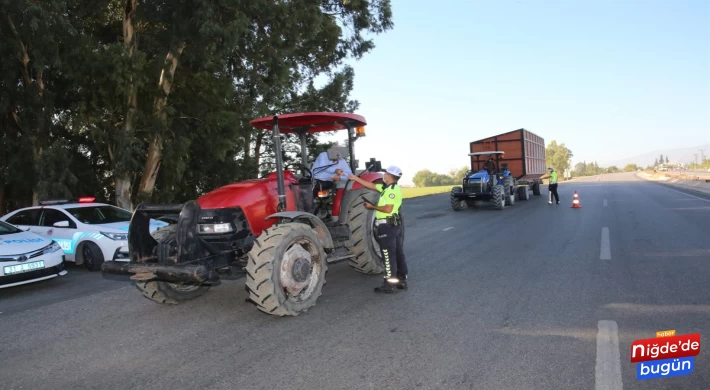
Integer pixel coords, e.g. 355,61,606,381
0,0,393,212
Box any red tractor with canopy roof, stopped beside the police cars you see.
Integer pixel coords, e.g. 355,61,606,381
102,112,384,316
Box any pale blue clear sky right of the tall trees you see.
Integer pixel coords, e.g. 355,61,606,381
320,0,710,184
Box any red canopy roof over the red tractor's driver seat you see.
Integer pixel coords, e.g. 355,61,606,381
249,112,367,134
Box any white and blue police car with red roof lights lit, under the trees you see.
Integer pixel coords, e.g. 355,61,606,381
0,197,168,271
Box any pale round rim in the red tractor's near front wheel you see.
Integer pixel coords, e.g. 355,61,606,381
279,238,324,302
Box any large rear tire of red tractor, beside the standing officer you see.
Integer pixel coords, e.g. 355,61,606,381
347,188,386,275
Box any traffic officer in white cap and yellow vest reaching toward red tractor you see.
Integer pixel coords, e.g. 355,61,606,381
348,165,408,293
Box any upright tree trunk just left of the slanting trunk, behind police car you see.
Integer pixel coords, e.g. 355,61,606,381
114,0,138,211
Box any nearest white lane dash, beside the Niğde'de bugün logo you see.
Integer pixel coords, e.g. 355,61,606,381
595,320,623,390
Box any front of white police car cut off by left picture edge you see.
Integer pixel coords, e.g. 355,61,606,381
0,221,67,288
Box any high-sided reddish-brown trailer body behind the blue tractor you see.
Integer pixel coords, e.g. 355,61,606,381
470,129,546,184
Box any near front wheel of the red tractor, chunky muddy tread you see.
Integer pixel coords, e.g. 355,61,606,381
246,222,328,316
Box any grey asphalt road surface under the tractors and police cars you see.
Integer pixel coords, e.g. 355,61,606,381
0,173,710,390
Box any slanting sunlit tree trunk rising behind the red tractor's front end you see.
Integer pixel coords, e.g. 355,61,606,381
138,42,186,199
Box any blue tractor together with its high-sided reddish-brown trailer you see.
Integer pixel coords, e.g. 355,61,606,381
451,129,546,210
